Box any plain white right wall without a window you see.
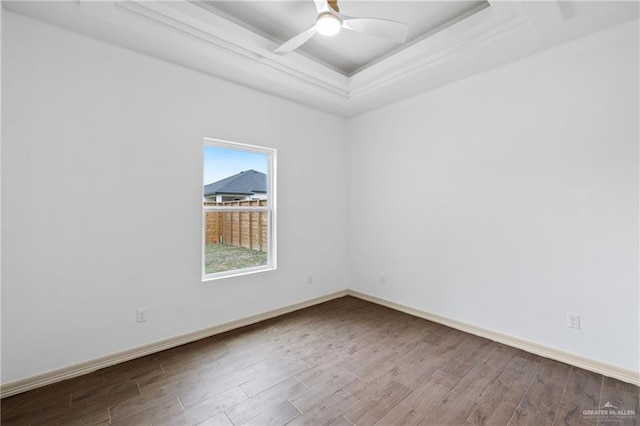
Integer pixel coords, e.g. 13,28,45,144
348,21,640,371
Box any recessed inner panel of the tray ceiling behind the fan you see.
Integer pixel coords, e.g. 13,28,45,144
194,0,489,76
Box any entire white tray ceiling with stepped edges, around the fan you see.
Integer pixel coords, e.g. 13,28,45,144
2,0,640,117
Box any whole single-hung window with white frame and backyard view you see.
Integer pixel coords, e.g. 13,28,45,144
202,138,276,280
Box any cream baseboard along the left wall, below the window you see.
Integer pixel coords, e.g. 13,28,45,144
0,290,347,398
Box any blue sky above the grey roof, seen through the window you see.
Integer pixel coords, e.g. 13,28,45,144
203,146,267,185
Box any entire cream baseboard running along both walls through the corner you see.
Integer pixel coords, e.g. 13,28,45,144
0,290,640,398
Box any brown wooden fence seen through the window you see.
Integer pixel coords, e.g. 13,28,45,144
204,200,268,251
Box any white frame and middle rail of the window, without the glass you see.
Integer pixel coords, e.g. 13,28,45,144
200,138,277,282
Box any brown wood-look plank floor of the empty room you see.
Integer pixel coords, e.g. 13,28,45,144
1,297,640,426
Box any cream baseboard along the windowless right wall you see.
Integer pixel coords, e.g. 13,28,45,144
347,290,640,386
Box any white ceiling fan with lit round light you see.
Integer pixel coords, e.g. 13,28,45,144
275,0,409,52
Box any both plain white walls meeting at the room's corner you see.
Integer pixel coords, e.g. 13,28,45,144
2,11,639,383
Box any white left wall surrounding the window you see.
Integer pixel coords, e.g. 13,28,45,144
2,11,347,383
